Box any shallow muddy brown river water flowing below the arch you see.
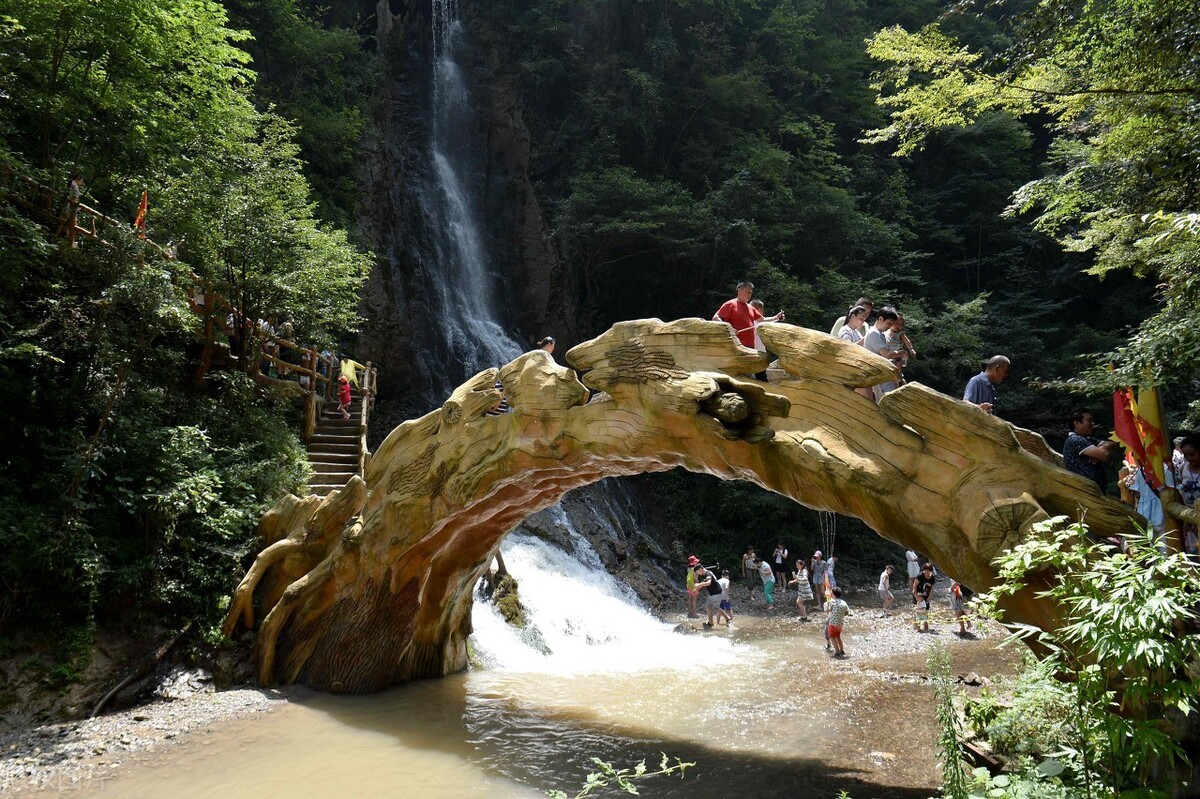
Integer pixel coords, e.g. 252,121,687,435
35,609,1016,799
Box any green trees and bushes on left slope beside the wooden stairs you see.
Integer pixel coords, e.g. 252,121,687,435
0,0,367,643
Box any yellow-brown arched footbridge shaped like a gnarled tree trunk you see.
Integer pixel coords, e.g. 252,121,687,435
226,319,1129,692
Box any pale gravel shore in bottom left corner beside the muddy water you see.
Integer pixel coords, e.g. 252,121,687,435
0,687,306,797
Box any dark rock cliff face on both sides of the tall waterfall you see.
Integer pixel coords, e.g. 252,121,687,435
355,6,580,438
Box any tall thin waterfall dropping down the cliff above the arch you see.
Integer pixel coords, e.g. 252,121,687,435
422,0,522,390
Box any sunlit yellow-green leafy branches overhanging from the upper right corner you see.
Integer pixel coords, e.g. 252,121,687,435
868,0,1200,405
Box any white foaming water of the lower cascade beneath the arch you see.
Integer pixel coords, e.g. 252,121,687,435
472,510,736,674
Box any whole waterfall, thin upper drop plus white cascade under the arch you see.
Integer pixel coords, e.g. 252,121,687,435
416,0,678,669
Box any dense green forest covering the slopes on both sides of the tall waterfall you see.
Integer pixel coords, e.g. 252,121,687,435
0,0,1200,710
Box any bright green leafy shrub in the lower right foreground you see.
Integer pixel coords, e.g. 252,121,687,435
986,517,1200,795
